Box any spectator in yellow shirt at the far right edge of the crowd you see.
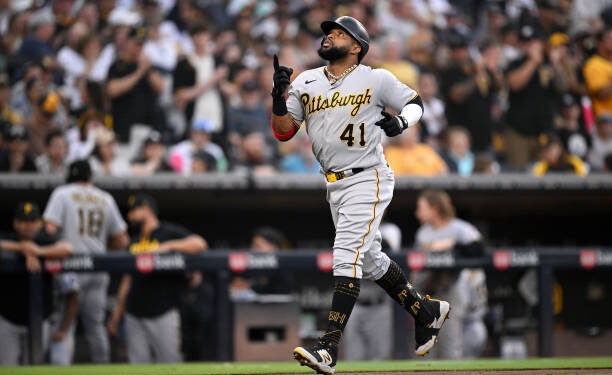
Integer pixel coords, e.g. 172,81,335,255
583,29,612,116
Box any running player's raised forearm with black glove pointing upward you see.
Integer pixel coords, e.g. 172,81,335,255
271,55,300,142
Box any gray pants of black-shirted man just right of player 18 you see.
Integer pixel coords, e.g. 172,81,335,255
125,309,182,363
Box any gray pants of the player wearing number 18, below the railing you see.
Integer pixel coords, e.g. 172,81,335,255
78,273,110,363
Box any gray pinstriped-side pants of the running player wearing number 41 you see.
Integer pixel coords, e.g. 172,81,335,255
327,166,395,280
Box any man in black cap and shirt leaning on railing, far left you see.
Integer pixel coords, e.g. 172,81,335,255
0,202,72,366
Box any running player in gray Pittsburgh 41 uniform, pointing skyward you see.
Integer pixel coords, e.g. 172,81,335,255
272,17,450,374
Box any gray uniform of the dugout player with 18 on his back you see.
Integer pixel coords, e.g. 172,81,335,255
43,184,127,363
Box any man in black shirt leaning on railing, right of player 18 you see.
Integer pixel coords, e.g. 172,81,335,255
108,194,207,363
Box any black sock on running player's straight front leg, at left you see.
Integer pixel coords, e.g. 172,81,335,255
321,276,360,346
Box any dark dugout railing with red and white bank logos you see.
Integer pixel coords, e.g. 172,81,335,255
0,247,612,364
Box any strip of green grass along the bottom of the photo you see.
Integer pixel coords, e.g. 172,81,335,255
0,357,612,375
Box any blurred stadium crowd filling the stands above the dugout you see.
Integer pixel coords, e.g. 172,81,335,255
0,0,612,176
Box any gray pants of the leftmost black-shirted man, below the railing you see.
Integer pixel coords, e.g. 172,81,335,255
0,315,49,366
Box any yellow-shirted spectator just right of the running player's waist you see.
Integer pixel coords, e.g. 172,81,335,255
385,126,448,176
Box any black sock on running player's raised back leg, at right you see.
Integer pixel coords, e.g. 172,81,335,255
376,261,423,319
